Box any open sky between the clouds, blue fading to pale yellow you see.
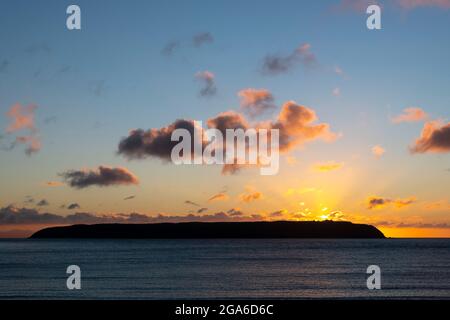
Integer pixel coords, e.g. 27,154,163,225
0,0,450,238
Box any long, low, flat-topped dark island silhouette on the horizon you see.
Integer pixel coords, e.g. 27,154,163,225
31,221,385,239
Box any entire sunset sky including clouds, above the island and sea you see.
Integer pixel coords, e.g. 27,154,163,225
0,0,450,237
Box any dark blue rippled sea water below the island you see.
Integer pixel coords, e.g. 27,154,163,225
0,239,450,299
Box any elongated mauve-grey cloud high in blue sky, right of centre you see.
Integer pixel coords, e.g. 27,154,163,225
262,43,316,75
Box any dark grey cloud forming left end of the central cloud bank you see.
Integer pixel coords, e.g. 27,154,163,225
118,120,205,161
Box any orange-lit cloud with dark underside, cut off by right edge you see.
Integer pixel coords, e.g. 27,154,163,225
410,121,450,153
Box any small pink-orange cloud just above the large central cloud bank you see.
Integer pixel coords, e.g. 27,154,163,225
238,88,276,117
